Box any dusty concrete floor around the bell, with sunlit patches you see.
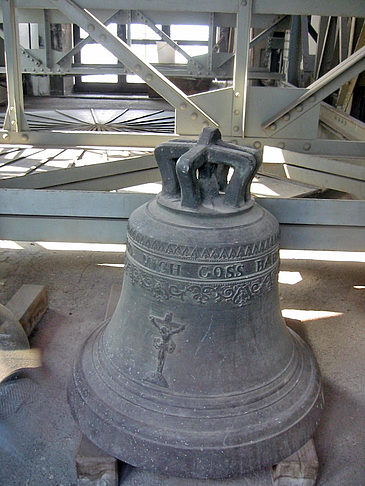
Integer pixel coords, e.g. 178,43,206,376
0,243,365,486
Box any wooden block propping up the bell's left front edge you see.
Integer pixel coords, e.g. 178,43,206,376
76,436,119,486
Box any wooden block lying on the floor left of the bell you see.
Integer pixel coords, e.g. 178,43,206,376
6,284,48,336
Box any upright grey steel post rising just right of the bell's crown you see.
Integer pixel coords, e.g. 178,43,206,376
232,0,252,136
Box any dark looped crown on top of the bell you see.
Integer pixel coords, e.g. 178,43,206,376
155,127,262,213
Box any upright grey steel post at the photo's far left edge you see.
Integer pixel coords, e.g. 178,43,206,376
1,0,28,132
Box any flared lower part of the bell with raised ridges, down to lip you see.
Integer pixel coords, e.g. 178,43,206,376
68,323,323,479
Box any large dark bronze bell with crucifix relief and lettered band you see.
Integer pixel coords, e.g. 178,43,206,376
69,128,322,479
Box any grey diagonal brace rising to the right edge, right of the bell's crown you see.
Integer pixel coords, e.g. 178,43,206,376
262,46,365,135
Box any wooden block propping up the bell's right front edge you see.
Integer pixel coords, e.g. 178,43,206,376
273,439,319,486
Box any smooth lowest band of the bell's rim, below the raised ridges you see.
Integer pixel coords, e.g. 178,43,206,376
67,360,324,480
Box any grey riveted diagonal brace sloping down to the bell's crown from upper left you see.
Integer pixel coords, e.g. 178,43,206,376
51,0,218,127
